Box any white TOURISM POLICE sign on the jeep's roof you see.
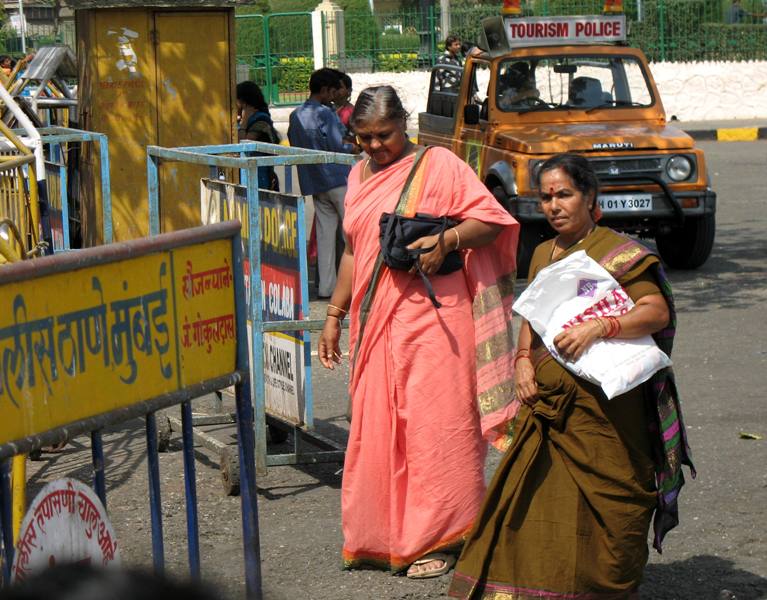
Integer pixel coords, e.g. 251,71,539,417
506,15,626,48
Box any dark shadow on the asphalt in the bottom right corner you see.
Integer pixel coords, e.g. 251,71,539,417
640,554,767,600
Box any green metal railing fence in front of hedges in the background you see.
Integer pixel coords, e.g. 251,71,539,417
236,0,767,105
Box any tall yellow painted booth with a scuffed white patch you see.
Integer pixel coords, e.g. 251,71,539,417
75,0,238,245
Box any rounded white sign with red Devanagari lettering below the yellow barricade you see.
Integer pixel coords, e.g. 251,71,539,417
11,478,120,581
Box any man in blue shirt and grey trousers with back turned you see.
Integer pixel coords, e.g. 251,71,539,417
288,69,355,298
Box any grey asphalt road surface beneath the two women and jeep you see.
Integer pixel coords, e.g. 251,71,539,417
25,142,767,600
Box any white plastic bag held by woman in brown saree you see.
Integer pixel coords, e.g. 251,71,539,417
513,250,671,399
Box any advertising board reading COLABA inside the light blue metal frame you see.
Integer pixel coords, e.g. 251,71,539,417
201,179,310,424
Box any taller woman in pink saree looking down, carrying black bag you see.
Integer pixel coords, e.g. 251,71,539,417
319,86,519,578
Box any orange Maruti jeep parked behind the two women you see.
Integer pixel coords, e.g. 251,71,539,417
418,16,716,276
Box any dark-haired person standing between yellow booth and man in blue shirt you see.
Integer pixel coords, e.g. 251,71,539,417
237,81,280,190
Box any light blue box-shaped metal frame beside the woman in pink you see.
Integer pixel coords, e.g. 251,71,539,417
147,142,357,473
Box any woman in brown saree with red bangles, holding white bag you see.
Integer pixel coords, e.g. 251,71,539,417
449,154,695,600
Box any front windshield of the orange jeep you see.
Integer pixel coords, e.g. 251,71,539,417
495,55,654,113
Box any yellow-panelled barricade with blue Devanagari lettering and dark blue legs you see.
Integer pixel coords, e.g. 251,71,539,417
0,221,261,598
